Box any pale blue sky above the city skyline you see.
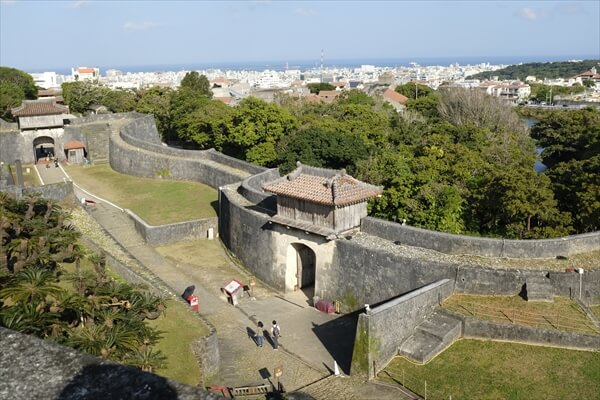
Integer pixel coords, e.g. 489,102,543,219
0,0,600,71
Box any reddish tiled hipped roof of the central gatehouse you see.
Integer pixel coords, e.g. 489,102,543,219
263,164,383,206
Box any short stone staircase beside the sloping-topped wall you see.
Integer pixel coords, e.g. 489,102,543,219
399,311,461,364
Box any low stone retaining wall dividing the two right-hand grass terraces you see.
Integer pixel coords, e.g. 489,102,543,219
441,310,600,351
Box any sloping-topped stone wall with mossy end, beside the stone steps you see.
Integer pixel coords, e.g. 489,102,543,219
352,279,454,379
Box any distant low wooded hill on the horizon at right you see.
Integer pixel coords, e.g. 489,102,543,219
467,60,600,80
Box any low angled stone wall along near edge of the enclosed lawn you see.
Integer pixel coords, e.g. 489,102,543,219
125,210,219,245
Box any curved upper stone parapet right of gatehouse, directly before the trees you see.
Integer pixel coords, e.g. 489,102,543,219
361,217,600,258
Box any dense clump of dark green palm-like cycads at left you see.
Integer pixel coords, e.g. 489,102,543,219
0,193,165,371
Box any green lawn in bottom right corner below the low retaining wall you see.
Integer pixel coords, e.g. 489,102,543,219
379,340,600,400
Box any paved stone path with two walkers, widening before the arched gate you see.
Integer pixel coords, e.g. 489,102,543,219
38,167,410,400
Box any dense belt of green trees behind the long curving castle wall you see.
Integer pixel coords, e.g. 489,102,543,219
4,68,600,238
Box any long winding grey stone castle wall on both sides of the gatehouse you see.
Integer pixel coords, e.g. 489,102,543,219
0,113,600,309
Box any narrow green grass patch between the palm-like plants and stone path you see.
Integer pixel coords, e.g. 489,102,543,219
148,300,209,386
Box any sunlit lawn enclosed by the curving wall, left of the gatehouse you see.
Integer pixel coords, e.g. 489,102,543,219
66,164,218,225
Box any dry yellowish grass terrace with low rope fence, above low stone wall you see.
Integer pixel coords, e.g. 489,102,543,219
442,294,600,335
